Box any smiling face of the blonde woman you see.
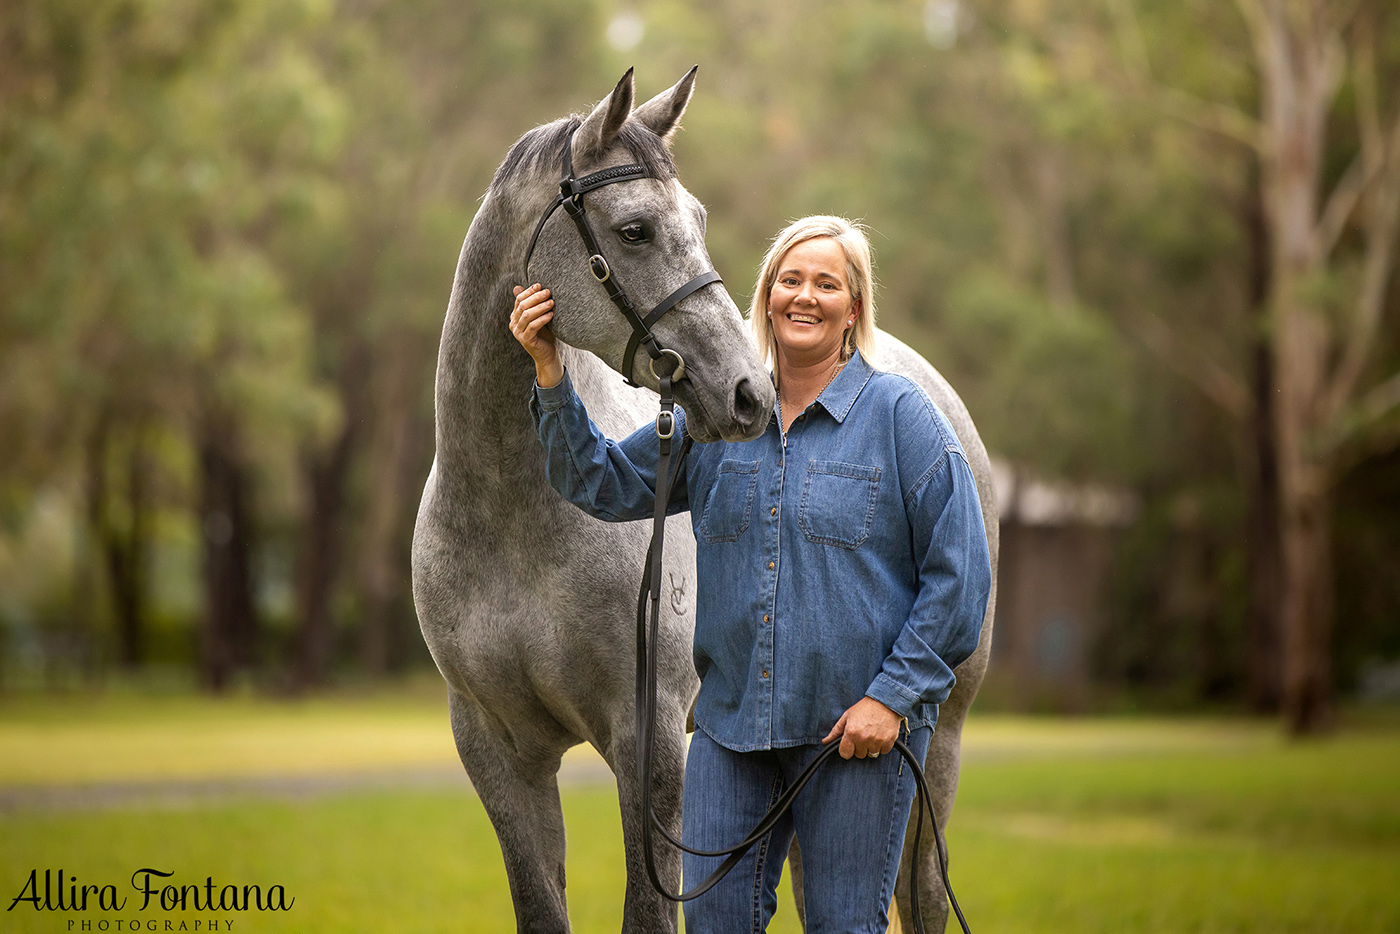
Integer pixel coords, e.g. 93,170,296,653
769,237,860,363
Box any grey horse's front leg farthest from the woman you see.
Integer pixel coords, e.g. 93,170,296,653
449,690,568,934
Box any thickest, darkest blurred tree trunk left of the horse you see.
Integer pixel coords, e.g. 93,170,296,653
199,414,259,690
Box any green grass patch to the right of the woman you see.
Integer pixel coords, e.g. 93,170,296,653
949,731,1400,934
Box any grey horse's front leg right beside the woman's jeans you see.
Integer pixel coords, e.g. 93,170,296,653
606,700,686,934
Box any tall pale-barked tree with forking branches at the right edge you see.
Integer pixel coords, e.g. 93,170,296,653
1238,0,1400,732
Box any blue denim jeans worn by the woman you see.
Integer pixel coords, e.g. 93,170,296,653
682,727,932,934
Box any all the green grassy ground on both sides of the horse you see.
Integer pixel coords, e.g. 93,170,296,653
0,688,1400,934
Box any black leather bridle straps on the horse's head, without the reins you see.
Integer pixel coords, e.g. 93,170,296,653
525,130,724,389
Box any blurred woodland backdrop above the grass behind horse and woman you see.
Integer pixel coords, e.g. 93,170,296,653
0,0,1400,732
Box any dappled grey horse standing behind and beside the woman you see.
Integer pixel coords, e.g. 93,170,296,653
413,69,995,933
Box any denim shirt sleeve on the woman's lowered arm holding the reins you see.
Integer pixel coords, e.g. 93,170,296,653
867,449,991,717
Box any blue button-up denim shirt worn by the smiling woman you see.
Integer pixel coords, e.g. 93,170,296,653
531,354,991,752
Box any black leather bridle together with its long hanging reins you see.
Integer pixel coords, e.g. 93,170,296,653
525,129,970,934
